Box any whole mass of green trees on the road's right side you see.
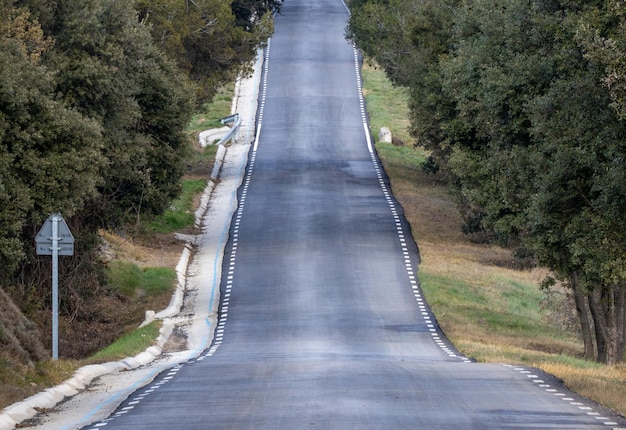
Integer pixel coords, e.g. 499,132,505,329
348,0,626,363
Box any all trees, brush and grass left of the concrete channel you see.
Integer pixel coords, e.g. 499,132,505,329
0,0,281,414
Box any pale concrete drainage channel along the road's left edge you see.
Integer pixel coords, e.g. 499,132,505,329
0,51,263,430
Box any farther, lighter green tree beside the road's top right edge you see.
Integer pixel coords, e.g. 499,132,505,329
346,0,458,160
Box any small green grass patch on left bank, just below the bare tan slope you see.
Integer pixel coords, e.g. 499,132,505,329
107,260,176,297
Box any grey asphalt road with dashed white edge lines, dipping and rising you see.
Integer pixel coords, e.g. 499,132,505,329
81,0,617,430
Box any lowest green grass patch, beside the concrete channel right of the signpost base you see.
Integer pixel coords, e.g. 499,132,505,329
87,321,161,363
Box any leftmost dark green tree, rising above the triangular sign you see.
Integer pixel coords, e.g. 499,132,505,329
0,0,104,280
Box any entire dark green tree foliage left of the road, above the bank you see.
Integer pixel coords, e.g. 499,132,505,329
0,0,280,286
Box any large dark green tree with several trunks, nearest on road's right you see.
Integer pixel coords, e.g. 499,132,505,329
442,0,626,363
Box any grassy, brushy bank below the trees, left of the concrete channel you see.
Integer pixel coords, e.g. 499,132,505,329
0,85,233,410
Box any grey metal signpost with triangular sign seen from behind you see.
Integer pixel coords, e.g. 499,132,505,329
35,213,74,360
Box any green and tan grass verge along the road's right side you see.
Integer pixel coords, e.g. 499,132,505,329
363,61,626,415
